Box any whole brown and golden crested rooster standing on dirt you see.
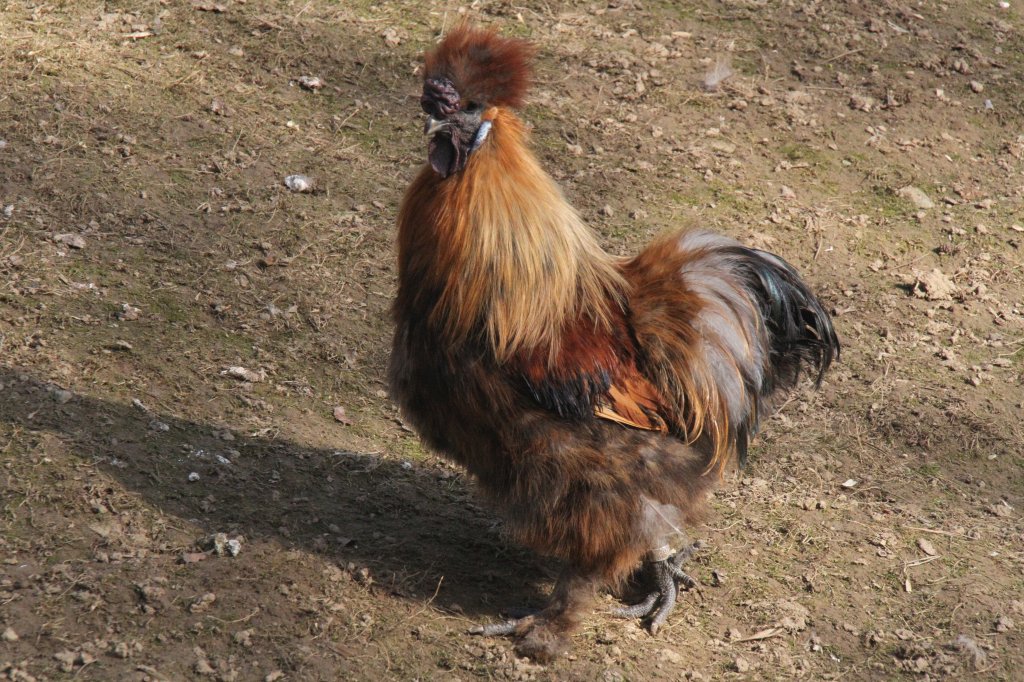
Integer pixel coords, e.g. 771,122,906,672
388,24,839,662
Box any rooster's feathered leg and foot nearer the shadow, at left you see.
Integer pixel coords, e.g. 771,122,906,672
469,568,596,663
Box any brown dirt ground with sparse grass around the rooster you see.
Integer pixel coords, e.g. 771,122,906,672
0,0,1024,681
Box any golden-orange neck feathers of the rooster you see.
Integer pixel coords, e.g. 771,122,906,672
398,109,626,360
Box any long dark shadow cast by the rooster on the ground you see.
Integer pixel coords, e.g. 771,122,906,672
0,366,544,617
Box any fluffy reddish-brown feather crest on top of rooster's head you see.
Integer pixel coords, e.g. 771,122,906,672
424,22,535,108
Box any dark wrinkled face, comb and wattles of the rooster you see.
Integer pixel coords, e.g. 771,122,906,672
420,78,483,177
